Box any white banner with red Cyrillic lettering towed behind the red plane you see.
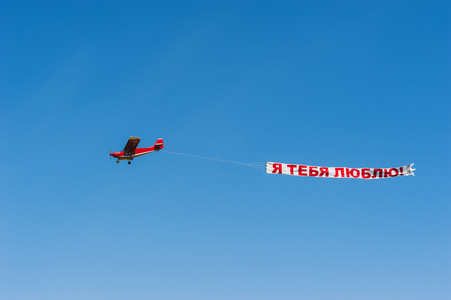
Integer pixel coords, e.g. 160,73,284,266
266,162,415,179
